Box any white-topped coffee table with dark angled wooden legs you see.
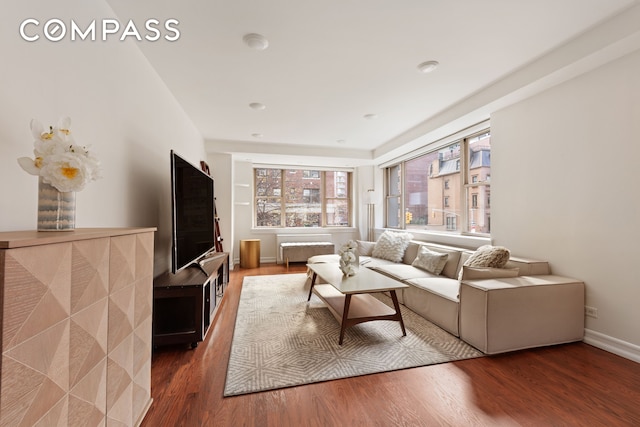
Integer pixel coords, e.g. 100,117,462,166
307,263,409,345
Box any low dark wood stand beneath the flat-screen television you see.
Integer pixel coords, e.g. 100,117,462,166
153,252,229,348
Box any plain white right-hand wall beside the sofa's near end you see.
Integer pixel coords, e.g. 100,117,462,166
491,46,640,357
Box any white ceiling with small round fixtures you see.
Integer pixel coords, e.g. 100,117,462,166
108,0,638,164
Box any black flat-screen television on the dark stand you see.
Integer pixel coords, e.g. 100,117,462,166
171,150,215,274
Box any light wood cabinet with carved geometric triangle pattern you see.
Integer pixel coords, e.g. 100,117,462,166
0,228,155,427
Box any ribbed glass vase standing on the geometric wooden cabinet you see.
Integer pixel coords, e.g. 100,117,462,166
38,177,76,231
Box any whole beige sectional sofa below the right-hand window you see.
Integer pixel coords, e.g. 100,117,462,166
308,234,584,354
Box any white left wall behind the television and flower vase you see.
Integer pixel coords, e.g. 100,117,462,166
0,0,205,274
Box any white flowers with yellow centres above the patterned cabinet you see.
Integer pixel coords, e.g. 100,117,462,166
18,117,101,193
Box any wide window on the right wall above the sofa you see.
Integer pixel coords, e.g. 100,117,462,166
385,131,491,234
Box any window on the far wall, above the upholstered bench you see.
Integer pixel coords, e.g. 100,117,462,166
254,168,351,227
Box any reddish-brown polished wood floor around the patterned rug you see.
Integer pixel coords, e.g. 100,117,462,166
142,264,640,427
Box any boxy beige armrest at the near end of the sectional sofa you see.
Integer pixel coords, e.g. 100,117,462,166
460,275,584,354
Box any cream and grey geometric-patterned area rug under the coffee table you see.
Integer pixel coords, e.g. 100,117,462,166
224,274,482,396
